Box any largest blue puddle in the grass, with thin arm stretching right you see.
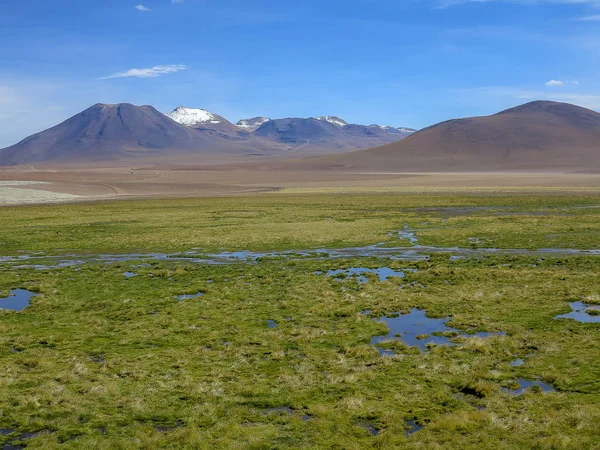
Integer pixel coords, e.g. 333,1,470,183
371,308,505,356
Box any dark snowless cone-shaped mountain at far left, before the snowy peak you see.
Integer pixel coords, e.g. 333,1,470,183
0,103,278,165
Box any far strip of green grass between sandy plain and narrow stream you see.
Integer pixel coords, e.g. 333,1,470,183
0,191,600,255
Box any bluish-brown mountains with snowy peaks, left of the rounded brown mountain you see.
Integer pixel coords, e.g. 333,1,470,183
0,103,415,165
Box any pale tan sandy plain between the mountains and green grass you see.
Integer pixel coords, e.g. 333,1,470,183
0,163,600,205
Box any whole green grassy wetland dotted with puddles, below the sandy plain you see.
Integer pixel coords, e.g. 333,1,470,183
0,192,600,449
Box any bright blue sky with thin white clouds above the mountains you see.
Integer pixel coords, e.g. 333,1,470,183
0,0,600,147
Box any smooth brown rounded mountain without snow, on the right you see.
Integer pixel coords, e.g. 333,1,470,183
299,101,600,172
